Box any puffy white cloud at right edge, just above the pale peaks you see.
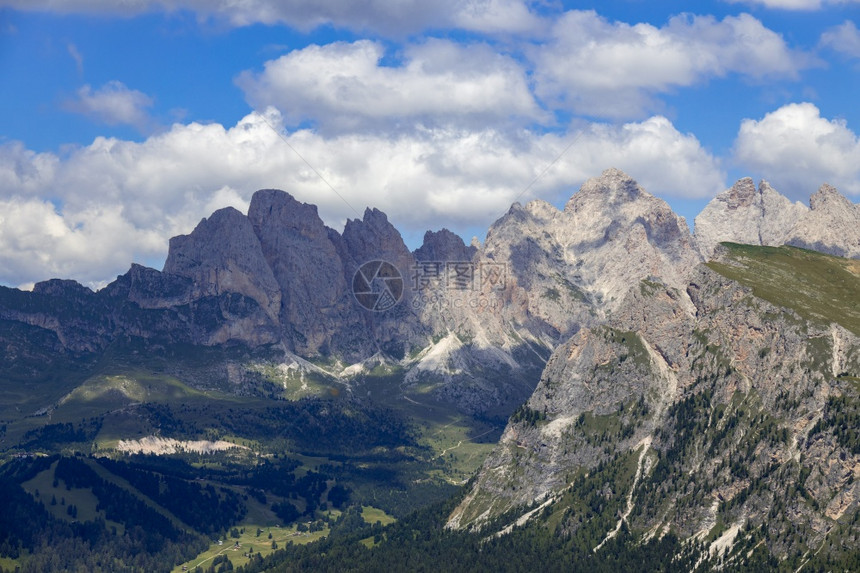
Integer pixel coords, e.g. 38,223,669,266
734,103,860,200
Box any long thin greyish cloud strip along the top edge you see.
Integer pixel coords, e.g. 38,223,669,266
3,0,541,36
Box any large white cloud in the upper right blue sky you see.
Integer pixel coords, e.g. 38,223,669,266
532,11,814,117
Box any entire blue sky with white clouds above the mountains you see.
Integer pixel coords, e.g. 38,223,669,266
0,0,860,286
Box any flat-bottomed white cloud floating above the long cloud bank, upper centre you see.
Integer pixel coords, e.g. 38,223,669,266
236,40,546,130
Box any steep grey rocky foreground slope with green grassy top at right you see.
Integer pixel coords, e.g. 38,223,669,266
449,245,860,565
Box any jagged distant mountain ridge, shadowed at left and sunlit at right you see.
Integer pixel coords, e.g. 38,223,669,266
0,169,860,416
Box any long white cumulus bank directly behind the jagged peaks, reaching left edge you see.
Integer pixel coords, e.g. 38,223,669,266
0,109,725,285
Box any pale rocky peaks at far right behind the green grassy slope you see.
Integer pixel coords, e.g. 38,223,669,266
695,178,860,259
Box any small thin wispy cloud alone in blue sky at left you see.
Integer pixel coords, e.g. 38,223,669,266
65,81,158,131
